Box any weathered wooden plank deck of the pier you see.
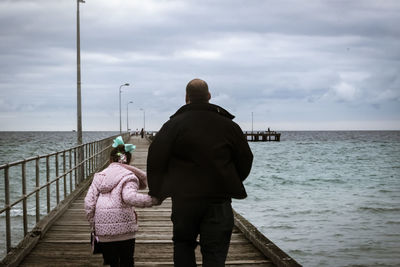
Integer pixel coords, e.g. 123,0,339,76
20,137,275,267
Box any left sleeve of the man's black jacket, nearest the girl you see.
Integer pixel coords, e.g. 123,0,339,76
147,122,173,200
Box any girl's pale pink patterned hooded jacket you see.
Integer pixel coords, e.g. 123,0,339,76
85,163,152,242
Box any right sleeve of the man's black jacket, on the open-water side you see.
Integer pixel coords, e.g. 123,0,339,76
233,123,253,181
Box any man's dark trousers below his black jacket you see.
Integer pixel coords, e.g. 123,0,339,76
171,198,233,267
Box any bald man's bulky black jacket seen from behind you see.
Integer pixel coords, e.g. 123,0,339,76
147,103,253,199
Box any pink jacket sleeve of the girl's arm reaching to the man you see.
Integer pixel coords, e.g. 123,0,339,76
122,177,153,208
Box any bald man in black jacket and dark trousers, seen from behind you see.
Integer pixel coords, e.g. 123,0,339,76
147,79,253,267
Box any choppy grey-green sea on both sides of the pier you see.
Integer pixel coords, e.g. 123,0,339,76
0,131,400,266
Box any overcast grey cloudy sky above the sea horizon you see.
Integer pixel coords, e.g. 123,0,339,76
0,0,400,131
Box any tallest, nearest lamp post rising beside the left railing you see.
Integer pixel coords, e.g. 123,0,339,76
75,0,85,184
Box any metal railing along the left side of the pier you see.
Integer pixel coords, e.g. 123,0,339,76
0,133,129,259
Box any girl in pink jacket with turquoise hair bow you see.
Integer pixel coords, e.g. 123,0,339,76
85,136,158,267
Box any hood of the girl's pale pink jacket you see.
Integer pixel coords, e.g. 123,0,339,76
95,163,133,193
